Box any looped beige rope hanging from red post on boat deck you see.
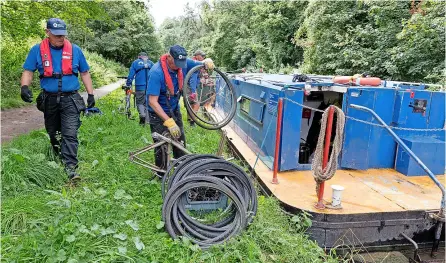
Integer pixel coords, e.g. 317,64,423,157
311,106,345,183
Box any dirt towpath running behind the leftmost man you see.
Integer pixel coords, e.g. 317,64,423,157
1,80,124,143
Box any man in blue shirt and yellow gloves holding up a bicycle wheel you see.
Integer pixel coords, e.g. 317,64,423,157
146,45,214,173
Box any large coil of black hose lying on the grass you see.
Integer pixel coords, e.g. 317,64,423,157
162,154,257,248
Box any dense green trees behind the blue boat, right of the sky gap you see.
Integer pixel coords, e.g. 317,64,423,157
160,0,446,84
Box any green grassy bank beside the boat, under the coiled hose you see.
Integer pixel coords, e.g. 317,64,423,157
1,91,336,263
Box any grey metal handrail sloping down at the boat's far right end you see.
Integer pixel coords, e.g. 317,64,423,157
350,104,445,213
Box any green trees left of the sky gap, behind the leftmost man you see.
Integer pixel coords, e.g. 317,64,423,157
1,0,162,64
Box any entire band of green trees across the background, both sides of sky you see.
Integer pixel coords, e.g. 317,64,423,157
1,0,446,84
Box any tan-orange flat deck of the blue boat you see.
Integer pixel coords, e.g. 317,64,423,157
223,126,445,214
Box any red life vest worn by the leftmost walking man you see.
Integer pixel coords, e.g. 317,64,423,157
39,38,77,78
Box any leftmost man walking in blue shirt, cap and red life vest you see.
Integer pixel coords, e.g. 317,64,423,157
21,18,95,180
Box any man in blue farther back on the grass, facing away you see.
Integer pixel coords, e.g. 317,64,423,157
126,52,153,125
